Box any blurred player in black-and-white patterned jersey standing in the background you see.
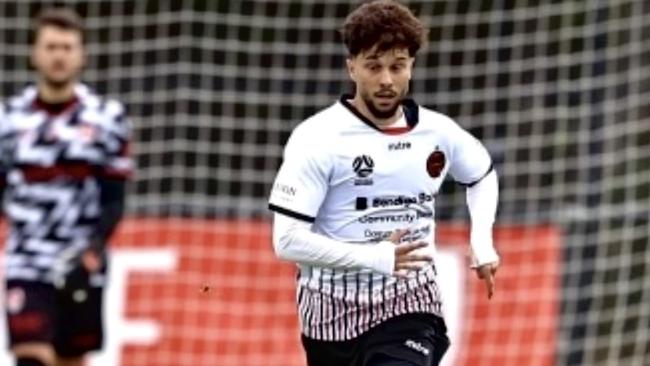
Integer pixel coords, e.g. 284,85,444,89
0,8,132,366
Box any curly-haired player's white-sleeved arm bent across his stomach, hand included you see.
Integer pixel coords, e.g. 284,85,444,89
269,125,431,275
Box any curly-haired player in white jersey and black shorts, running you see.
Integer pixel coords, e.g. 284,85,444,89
269,0,499,366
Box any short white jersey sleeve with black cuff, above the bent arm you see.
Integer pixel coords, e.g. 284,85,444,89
269,126,331,222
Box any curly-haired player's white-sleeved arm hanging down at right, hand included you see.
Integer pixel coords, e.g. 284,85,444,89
450,121,500,298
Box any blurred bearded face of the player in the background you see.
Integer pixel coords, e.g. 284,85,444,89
32,26,85,87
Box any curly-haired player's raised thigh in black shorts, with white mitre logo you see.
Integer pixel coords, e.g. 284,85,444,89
362,314,449,366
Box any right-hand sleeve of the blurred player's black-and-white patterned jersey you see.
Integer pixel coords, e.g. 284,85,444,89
102,100,133,179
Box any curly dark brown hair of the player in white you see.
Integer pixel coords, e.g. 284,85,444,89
341,0,427,57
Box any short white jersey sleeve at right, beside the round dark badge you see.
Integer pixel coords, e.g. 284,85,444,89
449,123,493,186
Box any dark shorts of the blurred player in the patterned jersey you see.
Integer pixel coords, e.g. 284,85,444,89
5,281,104,357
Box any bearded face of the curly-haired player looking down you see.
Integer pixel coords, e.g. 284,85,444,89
348,48,413,119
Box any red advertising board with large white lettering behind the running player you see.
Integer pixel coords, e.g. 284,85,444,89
0,219,561,366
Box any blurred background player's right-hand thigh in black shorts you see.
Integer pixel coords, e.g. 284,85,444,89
53,288,104,358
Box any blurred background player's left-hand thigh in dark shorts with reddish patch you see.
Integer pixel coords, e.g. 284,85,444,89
5,281,56,349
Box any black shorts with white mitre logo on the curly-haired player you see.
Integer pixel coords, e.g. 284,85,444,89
302,313,449,366
